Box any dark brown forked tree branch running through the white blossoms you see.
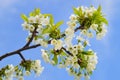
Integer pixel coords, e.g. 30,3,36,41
0,26,84,61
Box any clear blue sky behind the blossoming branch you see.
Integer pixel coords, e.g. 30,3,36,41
0,0,120,80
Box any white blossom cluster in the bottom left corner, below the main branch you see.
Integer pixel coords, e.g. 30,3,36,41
0,60,44,80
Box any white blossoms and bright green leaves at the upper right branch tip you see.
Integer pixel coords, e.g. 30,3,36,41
74,6,108,39
